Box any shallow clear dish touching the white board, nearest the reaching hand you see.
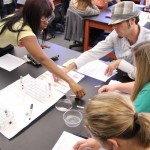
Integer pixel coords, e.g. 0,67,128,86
55,99,72,112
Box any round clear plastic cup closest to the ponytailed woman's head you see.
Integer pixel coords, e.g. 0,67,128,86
63,109,83,127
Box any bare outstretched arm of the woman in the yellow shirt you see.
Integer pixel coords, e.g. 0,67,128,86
21,36,85,98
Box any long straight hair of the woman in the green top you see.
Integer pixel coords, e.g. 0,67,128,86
131,41,150,101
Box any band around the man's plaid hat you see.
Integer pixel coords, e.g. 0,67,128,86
111,11,139,20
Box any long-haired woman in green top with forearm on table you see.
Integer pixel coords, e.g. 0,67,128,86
99,41,150,112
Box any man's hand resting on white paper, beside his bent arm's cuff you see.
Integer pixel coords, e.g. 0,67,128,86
105,59,121,76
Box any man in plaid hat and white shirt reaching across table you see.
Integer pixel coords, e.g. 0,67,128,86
64,1,150,79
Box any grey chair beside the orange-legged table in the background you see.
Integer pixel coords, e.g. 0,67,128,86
65,9,84,49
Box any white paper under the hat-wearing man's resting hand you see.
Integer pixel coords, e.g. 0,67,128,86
77,60,117,82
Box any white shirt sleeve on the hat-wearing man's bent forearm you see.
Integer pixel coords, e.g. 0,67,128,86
118,59,136,79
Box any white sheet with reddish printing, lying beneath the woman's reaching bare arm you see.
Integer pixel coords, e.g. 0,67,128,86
38,66,84,93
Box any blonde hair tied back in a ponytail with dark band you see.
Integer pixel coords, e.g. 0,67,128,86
85,92,150,148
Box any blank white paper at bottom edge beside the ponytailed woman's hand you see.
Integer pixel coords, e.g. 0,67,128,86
52,131,83,150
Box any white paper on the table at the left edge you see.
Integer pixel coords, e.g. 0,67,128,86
0,54,25,71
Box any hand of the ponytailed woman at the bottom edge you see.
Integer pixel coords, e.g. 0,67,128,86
73,138,100,150
